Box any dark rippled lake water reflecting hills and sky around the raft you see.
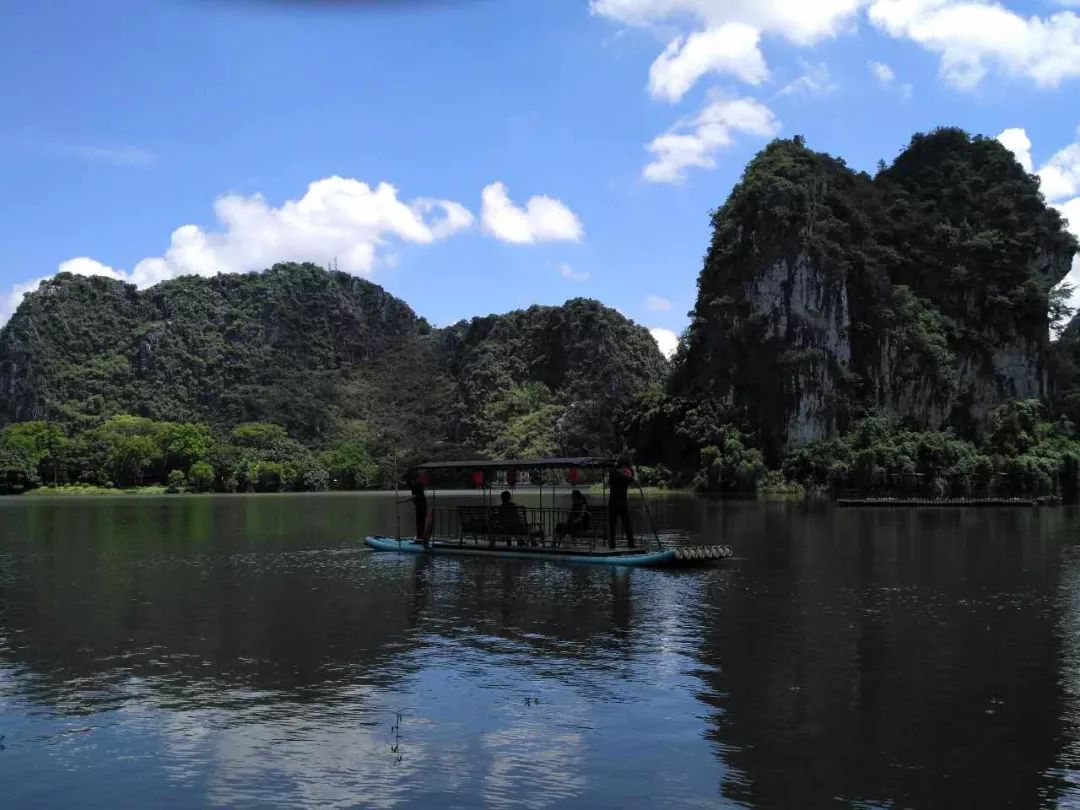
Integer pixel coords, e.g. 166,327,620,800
0,495,1080,808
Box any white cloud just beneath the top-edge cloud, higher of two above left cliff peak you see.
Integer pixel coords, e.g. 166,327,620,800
649,23,769,102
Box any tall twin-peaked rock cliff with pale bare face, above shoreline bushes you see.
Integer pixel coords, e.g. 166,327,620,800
672,130,1076,459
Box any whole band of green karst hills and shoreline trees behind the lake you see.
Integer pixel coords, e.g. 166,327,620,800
0,129,1080,495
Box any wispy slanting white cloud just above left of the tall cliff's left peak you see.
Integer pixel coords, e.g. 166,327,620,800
643,98,780,183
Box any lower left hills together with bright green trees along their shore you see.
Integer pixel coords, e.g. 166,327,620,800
0,265,666,491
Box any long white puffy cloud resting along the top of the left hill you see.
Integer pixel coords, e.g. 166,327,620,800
0,176,473,323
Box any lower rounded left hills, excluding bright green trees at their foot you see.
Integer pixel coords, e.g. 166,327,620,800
0,265,666,460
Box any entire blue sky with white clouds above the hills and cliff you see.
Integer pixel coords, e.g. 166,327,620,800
0,0,1080,351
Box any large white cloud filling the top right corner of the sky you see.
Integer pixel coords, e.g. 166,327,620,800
869,0,1080,89
